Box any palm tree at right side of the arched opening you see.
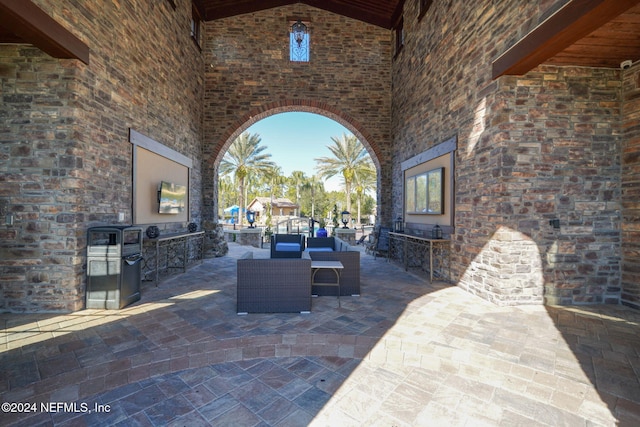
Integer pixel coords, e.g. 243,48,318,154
314,134,371,211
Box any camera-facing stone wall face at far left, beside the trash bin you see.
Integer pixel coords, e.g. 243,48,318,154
0,45,82,311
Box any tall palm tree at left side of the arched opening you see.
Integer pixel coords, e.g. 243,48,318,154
220,132,275,225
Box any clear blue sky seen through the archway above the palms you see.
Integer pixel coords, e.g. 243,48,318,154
247,112,352,191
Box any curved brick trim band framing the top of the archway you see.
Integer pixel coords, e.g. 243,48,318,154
213,99,384,171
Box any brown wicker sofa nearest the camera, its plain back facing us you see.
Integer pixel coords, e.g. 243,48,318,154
236,256,311,314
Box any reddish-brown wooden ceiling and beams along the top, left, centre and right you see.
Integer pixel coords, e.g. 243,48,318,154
0,0,640,78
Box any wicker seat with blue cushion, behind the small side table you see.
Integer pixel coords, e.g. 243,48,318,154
305,237,360,296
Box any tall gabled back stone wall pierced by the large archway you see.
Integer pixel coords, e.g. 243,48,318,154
204,4,391,224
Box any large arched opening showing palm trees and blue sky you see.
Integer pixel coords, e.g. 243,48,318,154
218,112,378,232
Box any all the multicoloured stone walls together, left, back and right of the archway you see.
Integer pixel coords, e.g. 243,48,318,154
0,0,640,312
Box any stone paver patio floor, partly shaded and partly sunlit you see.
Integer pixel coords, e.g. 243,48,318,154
0,244,640,426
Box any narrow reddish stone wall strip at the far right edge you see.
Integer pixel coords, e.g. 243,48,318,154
621,65,640,309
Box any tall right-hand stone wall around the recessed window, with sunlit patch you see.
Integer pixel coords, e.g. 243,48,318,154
392,0,621,304
